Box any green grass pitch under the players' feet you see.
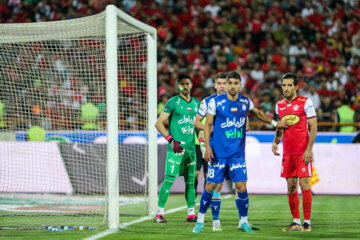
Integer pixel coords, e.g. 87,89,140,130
0,195,360,240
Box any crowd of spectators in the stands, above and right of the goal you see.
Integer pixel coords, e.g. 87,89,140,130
0,0,360,131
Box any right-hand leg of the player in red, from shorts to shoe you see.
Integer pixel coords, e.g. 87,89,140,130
298,155,312,232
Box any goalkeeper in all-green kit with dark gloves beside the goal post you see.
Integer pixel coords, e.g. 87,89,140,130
154,73,200,223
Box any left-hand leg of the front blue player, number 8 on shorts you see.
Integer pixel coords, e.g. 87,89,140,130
193,158,226,233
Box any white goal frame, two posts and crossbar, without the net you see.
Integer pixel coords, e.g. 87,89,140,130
106,5,157,229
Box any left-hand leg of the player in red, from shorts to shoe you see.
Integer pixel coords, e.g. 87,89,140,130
281,156,301,231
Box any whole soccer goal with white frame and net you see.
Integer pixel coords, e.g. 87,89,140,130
0,5,158,229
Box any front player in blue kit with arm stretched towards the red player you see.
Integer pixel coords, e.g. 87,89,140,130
193,72,288,233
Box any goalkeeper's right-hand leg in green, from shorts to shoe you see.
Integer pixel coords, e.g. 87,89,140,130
183,153,196,222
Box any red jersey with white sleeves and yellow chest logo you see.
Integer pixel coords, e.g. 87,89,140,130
275,96,316,156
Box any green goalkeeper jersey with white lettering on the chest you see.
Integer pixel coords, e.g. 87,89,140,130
163,95,200,153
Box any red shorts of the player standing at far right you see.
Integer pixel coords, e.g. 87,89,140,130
280,154,312,178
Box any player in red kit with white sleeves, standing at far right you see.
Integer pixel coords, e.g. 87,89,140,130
272,73,317,231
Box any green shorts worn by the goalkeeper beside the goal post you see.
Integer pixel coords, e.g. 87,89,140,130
165,151,196,177
